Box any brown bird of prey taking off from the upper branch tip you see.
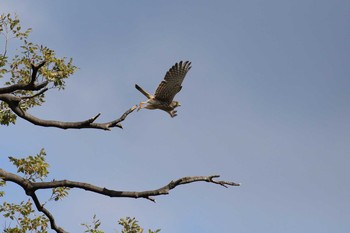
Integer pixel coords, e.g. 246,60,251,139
135,61,191,117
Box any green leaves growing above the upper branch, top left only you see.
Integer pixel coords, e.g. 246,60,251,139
0,14,77,89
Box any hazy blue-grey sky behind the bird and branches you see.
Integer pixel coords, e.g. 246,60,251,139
0,0,350,233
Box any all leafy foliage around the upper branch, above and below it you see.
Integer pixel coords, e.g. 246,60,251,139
0,14,77,126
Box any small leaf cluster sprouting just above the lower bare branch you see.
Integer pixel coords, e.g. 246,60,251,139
9,149,49,181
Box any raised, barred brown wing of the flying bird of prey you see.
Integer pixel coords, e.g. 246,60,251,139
155,61,191,103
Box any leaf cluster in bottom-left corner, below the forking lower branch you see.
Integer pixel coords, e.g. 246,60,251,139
0,200,49,233
